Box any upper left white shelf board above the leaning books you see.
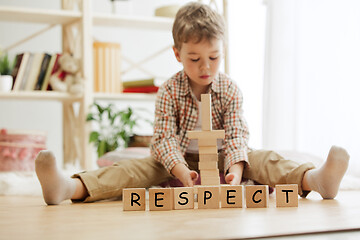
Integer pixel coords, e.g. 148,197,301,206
0,6,82,24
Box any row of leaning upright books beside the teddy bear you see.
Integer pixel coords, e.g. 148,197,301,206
12,52,61,91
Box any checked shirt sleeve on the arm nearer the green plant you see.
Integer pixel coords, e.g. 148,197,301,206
150,86,188,173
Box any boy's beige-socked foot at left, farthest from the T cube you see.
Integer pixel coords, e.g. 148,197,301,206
35,151,76,205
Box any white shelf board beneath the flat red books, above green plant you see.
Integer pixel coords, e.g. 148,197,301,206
94,93,156,101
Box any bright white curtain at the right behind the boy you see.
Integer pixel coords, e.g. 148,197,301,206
263,0,360,175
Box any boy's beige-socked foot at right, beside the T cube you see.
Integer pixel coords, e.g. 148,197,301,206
304,146,350,199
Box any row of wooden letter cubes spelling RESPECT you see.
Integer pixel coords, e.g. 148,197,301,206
123,184,299,211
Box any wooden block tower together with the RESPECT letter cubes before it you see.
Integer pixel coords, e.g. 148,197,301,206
123,94,298,211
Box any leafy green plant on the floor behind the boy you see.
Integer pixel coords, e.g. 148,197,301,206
86,103,150,157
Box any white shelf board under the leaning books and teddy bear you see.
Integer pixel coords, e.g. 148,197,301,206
0,91,82,102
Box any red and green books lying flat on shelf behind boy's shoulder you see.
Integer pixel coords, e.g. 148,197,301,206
123,78,159,93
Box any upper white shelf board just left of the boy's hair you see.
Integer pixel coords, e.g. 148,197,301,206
93,13,174,31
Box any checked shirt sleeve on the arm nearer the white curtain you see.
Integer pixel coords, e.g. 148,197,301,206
224,85,249,174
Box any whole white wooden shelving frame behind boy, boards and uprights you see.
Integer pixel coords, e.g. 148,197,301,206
0,0,228,169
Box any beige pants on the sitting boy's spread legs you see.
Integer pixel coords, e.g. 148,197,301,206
73,150,315,202
